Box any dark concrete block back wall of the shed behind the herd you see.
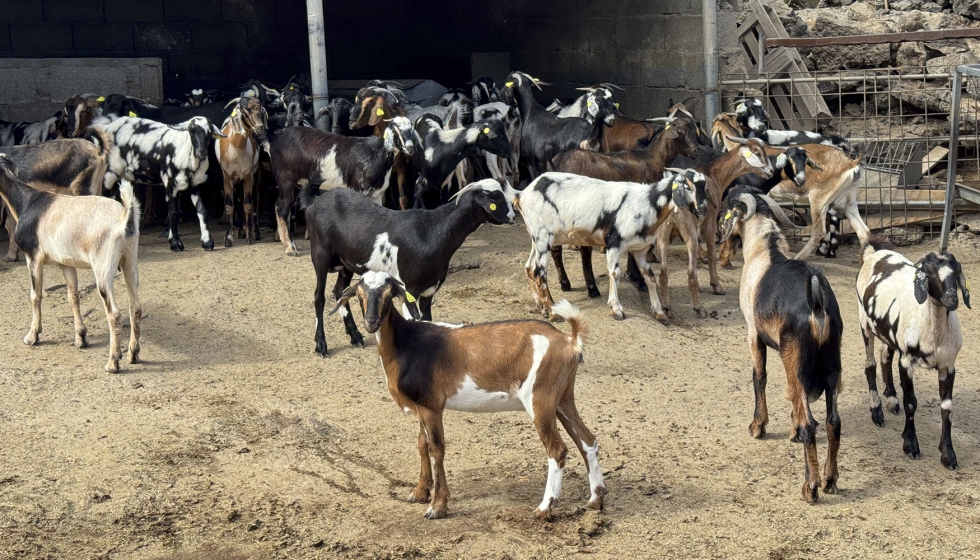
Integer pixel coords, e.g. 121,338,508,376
0,0,704,116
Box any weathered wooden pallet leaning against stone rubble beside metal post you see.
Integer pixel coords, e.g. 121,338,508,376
737,0,831,130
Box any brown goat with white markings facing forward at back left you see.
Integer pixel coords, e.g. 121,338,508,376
214,97,269,247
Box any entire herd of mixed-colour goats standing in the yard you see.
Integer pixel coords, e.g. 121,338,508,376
0,72,970,518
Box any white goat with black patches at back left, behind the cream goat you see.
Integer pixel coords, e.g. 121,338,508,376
105,117,225,252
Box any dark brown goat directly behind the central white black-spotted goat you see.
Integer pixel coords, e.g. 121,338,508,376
551,118,699,298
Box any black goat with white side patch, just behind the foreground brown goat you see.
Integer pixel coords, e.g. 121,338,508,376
300,179,514,358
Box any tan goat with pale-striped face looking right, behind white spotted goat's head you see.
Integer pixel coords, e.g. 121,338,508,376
657,139,773,318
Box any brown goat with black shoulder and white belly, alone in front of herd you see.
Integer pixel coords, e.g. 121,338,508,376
331,271,606,519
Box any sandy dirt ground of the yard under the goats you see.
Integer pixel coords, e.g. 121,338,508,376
0,220,980,559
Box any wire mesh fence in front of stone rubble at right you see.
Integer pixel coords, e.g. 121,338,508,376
720,65,980,241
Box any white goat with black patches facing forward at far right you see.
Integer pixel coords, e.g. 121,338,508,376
856,236,970,470
